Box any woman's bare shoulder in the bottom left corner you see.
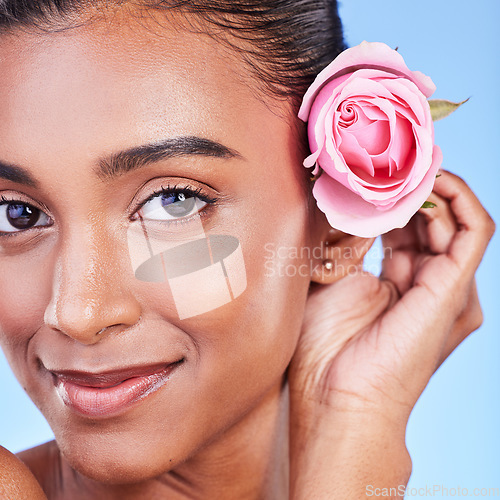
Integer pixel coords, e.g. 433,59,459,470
0,446,46,500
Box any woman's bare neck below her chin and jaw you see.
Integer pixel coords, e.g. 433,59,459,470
27,378,289,500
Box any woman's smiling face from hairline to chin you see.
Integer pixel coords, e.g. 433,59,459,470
0,10,310,482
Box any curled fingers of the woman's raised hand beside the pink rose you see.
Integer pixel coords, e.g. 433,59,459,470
382,171,495,294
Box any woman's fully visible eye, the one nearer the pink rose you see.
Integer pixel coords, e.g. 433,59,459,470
137,192,207,220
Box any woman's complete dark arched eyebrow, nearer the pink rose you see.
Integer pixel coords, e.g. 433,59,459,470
97,136,243,179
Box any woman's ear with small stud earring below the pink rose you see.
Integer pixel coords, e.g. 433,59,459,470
311,208,375,285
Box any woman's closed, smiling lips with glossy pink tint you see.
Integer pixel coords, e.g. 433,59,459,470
52,360,183,418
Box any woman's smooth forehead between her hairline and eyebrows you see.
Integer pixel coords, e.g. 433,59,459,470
0,10,266,167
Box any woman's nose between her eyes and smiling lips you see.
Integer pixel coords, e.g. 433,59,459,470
45,227,141,344
